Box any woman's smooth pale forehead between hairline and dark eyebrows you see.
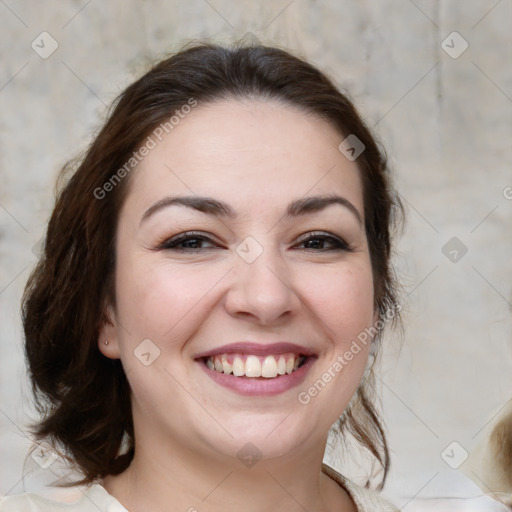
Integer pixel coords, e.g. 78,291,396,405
126,100,363,215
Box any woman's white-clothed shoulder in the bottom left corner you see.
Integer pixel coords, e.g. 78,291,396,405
0,484,127,512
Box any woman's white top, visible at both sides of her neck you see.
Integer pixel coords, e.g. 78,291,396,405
0,468,400,512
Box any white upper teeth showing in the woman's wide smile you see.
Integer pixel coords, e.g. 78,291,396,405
206,353,301,379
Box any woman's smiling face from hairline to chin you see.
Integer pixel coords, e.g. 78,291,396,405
99,100,375,466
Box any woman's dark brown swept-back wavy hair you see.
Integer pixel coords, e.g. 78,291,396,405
22,44,401,488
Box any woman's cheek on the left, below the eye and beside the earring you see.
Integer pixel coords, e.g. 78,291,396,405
112,257,219,416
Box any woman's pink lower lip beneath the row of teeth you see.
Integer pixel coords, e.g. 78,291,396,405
198,357,316,396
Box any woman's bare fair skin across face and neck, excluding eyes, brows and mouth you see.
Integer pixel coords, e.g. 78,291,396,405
98,100,376,512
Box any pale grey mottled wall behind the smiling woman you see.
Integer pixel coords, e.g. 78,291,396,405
0,0,512,511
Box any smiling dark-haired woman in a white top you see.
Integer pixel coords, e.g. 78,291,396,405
0,45,400,512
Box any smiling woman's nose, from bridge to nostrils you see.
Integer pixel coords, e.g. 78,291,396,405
225,243,300,325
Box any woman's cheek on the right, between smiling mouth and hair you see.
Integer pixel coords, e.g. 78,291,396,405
298,260,374,425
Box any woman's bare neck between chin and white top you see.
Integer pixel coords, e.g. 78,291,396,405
104,434,356,512
